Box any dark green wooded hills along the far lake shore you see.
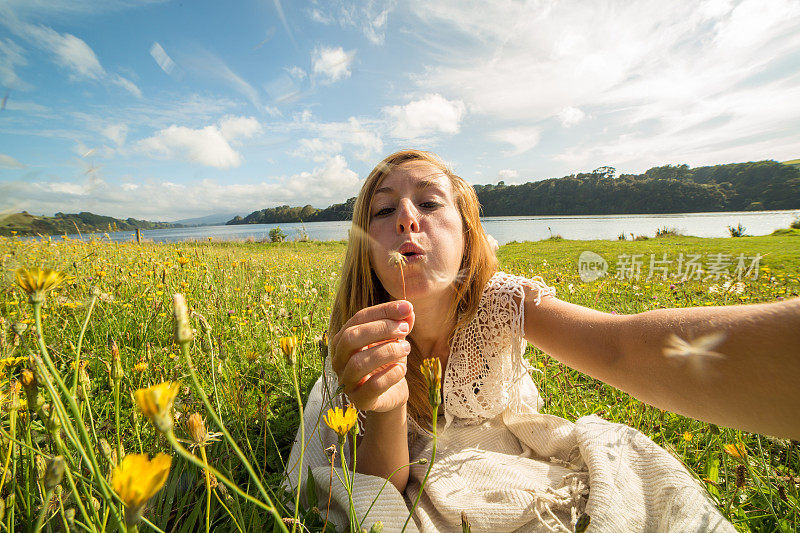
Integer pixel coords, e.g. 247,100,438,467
228,160,800,224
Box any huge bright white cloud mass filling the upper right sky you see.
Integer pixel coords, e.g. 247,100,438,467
410,0,800,164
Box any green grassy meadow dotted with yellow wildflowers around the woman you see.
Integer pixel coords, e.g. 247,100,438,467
0,232,800,531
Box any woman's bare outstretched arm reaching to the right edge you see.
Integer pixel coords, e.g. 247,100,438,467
525,289,800,439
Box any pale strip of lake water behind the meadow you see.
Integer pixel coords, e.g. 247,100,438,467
67,209,800,244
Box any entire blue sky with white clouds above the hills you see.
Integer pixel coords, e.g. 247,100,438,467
0,0,800,220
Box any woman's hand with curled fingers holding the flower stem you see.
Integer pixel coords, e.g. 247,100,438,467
331,300,414,412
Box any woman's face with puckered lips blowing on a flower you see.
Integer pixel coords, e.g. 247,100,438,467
369,161,464,302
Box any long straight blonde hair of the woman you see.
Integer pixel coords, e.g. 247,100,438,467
329,150,497,426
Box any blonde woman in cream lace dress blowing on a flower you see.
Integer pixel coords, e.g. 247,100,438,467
289,150,800,531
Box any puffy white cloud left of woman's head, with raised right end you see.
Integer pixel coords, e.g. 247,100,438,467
136,117,261,168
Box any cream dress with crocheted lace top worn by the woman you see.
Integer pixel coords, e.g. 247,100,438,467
287,272,735,532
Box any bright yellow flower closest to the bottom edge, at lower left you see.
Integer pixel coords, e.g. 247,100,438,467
111,453,172,526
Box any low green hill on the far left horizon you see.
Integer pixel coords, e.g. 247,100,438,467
0,211,182,237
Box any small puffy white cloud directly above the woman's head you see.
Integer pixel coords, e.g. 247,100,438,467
384,94,466,140
